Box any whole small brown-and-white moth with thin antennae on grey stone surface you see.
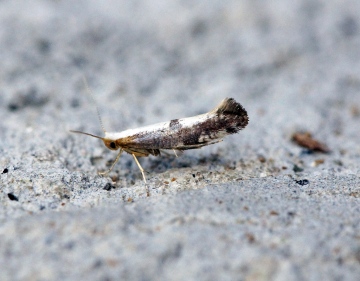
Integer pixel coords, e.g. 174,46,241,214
70,98,249,184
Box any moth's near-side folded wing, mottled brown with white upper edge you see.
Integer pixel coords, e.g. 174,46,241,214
117,98,249,152
